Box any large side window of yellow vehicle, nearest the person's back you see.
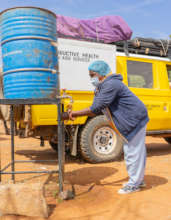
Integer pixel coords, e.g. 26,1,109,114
127,60,153,88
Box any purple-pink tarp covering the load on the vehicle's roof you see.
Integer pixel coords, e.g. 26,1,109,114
57,15,132,43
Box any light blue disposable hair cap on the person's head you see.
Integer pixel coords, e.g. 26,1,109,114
88,60,111,76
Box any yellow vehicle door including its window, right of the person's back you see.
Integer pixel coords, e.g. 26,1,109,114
119,57,171,131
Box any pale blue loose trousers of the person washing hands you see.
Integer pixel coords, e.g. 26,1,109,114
123,126,146,186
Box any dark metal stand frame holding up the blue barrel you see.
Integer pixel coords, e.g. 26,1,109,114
0,96,67,192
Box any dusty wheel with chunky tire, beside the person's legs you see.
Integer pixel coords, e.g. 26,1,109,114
80,115,123,163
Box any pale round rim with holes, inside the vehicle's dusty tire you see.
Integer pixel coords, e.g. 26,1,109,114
93,126,117,155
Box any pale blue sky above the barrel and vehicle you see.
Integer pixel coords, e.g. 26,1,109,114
0,0,171,39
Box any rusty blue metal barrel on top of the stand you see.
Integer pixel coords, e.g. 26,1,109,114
0,7,58,99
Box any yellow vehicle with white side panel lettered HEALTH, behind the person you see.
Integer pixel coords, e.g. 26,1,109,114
9,39,171,163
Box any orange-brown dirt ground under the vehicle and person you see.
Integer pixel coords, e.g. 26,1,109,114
0,124,171,220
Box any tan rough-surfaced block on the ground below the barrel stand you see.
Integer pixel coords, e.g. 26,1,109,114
0,183,48,218
